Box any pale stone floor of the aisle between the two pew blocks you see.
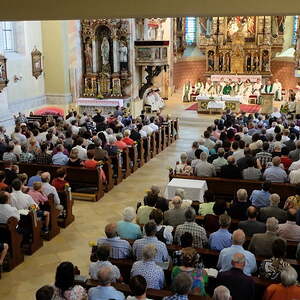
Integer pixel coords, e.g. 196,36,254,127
0,96,214,300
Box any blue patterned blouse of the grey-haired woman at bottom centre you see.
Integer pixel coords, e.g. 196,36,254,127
131,260,165,290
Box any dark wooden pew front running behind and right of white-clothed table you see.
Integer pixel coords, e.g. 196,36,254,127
169,173,296,207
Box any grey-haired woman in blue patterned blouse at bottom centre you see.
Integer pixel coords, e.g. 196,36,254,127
130,244,165,290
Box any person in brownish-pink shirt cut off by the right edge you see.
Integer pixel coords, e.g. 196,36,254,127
278,208,300,242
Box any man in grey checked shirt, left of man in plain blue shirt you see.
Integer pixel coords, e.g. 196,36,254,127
174,207,207,248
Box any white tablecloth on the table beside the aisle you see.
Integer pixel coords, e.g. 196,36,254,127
165,178,207,202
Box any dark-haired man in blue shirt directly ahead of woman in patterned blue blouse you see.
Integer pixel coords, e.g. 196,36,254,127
132,221,169,263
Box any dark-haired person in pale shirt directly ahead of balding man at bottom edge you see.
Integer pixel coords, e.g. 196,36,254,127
89,245,121,282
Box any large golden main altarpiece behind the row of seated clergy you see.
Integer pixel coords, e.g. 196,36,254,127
178,16,285,76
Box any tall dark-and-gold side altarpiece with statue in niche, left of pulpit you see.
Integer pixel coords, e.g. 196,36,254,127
81,19,131,99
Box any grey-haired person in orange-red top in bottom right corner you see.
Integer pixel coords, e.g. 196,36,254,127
264,266,300,300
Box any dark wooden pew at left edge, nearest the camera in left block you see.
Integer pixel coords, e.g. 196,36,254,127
0,217,24,271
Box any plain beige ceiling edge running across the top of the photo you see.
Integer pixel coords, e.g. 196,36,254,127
0,0,300,20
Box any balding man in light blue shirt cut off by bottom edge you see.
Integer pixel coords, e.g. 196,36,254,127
88,267,125,300
